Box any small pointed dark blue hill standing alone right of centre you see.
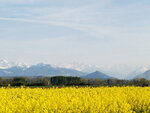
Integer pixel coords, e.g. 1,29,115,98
82,71,113,80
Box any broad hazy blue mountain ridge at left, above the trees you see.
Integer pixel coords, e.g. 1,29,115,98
0,63,87,76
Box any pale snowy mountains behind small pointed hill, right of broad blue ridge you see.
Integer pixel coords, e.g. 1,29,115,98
53,63,150,79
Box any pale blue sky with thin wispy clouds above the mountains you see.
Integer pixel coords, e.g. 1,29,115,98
0,0,150,66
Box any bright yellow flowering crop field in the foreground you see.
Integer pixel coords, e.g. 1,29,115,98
0,87,150,113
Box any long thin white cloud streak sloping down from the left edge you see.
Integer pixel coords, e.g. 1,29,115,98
0,17,119,36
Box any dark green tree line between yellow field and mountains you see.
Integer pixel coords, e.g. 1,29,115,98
0,76,150,87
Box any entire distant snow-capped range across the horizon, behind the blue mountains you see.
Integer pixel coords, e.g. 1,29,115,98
0,60,150,79
